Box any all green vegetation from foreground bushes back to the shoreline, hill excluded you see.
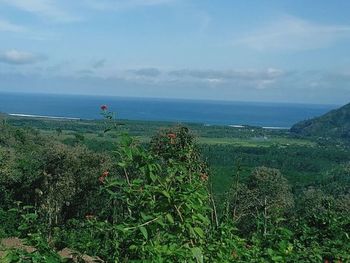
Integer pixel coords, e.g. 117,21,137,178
0,108,350,263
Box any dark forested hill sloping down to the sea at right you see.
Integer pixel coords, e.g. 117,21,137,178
291,103,350,139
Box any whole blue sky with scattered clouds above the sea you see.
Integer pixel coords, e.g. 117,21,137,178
0,0,350,104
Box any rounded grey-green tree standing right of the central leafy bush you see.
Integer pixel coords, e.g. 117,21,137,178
230,167,294,235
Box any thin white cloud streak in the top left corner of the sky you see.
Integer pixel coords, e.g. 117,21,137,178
0,0,79,22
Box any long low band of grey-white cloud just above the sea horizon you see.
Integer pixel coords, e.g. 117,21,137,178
0,68,350,104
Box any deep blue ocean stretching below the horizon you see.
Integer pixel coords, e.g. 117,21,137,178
0,93,338,128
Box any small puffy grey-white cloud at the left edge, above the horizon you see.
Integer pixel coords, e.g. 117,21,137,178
0,49,43,65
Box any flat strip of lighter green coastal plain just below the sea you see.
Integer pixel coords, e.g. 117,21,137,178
7,114,315,147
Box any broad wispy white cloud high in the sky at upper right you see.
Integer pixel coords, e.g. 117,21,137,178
233,16,350,51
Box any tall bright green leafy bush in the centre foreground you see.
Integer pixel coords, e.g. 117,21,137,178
95,129,210,262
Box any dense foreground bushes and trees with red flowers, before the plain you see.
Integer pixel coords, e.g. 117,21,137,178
0,114,350,263
